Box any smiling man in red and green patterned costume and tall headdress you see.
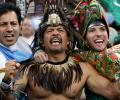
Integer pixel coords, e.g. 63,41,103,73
71,0,120,100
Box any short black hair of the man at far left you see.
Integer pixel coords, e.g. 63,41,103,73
0,3,22,24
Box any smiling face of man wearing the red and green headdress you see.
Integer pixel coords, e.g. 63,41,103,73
86,23,108,51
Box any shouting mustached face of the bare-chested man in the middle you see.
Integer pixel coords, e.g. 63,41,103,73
44,25,69,53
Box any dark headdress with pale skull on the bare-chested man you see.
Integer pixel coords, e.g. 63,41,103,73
39,0,74,49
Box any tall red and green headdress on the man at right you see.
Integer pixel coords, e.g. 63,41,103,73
71,0,109,49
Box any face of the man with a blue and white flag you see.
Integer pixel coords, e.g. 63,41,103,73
0,11,19,46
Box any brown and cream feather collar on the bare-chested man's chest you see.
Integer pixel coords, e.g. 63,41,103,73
19,57,82,94
